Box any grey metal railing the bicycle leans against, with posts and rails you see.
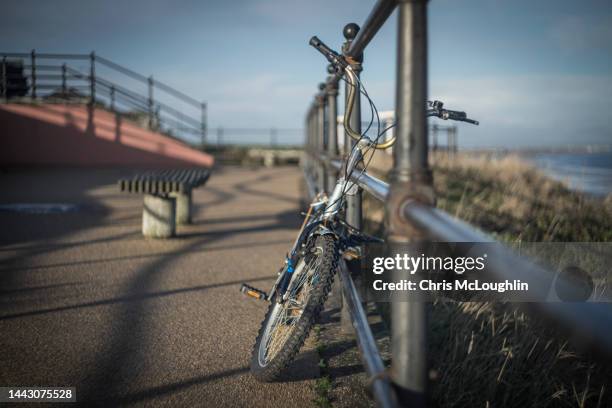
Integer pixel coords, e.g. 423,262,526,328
303,0,612,407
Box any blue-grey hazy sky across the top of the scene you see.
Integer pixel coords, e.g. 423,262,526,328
0,0,612,148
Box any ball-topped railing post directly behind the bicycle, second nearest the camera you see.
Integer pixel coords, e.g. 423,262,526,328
340,23,365,333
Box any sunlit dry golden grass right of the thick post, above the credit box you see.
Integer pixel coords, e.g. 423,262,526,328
434,156,612,242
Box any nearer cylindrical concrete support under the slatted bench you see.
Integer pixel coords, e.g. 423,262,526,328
142,194,176,238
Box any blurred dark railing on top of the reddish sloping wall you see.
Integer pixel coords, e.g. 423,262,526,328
0,50,207,145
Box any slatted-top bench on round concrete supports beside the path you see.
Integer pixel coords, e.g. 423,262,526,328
119,168,210,238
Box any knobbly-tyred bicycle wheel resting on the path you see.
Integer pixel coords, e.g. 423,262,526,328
251,235,338,381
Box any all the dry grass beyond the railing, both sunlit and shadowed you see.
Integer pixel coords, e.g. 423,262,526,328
364,155,612,407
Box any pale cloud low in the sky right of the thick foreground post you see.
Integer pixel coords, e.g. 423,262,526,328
430,75,612,148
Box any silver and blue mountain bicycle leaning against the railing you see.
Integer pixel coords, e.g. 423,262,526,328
241,37,478,381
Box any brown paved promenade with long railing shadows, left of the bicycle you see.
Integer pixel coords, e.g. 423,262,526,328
0,167,318,407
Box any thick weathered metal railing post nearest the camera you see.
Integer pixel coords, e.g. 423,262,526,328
385,0,434,406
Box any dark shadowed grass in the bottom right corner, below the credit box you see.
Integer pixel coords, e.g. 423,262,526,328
430,302,612,407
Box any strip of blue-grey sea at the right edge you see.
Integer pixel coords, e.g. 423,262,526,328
528,152,612,197
